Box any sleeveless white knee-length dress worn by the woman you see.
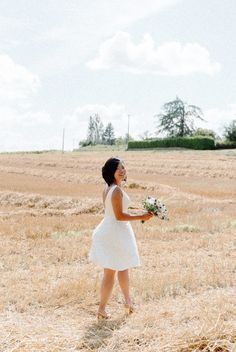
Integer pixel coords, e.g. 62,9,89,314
89,185,140,271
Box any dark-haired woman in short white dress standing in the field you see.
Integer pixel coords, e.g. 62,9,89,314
89,158,153,319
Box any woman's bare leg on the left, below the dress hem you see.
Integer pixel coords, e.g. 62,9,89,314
98,269,116,313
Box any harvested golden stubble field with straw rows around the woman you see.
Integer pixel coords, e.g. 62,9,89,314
0,150,236,352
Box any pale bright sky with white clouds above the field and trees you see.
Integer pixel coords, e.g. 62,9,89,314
0,0,236,152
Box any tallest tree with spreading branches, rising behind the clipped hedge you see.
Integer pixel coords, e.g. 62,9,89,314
156,97,204,137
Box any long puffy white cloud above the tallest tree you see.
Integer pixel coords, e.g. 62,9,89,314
87,32,220,76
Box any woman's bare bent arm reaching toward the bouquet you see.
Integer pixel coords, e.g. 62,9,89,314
111,187,153,221
